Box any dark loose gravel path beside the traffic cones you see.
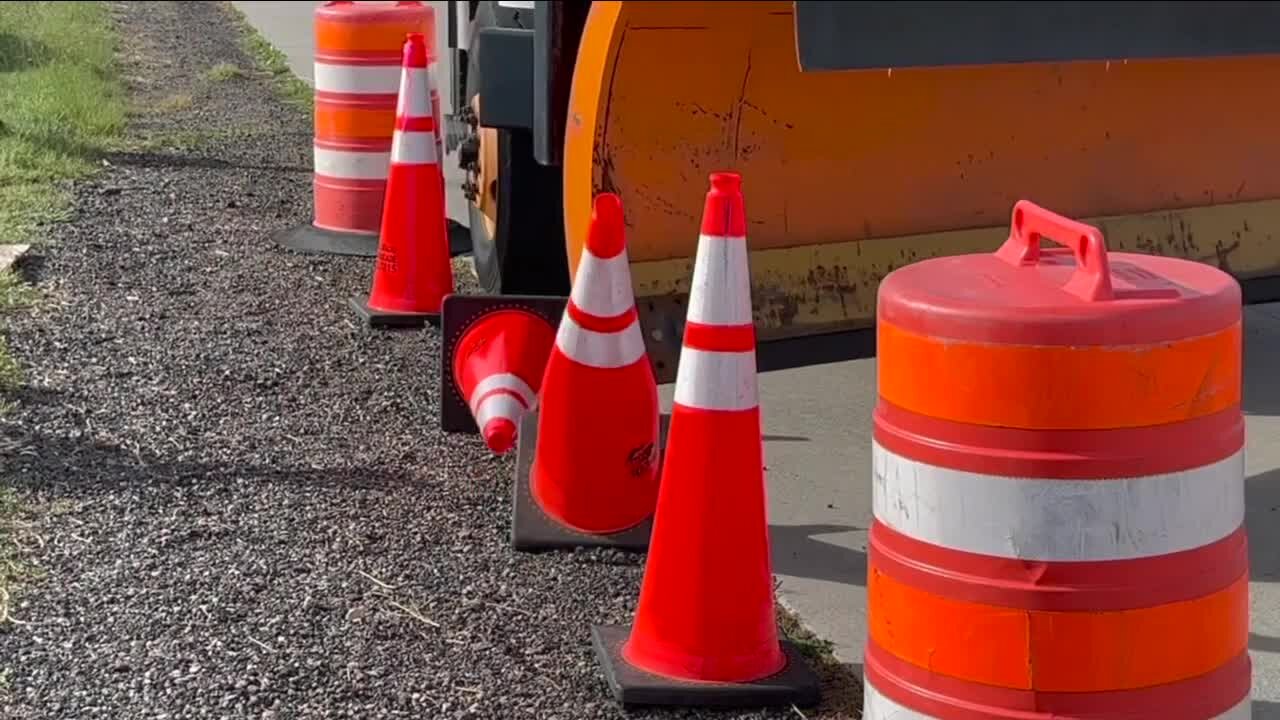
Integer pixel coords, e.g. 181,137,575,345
0,3,851,720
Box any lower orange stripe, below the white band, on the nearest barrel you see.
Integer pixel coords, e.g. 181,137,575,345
867,564,1249,692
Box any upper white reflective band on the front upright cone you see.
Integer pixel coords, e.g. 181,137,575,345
687,234,753,325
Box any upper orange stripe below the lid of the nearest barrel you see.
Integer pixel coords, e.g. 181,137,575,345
877,319,1242,429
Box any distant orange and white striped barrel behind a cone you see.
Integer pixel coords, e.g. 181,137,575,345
282,1,439,258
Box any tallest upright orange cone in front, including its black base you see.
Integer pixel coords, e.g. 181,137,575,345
591,173,818,705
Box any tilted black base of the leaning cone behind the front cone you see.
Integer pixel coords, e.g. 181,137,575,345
511,411,667,552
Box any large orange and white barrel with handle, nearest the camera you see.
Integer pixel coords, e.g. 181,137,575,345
864,201,1251,720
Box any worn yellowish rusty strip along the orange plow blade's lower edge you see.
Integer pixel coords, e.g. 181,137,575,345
631,200,1280,382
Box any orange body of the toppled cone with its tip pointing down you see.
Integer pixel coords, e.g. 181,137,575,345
453,304,556,455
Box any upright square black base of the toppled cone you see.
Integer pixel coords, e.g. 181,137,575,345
440,289,568,434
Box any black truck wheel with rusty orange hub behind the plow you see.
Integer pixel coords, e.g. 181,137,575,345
463,3,570,295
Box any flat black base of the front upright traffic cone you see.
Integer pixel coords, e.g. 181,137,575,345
591,625,822,707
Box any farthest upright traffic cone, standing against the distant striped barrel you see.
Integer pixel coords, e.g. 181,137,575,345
352,32,453,328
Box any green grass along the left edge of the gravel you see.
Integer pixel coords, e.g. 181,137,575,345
0,3,127,625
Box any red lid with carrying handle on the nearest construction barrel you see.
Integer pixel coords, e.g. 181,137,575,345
877,201,1240,346
